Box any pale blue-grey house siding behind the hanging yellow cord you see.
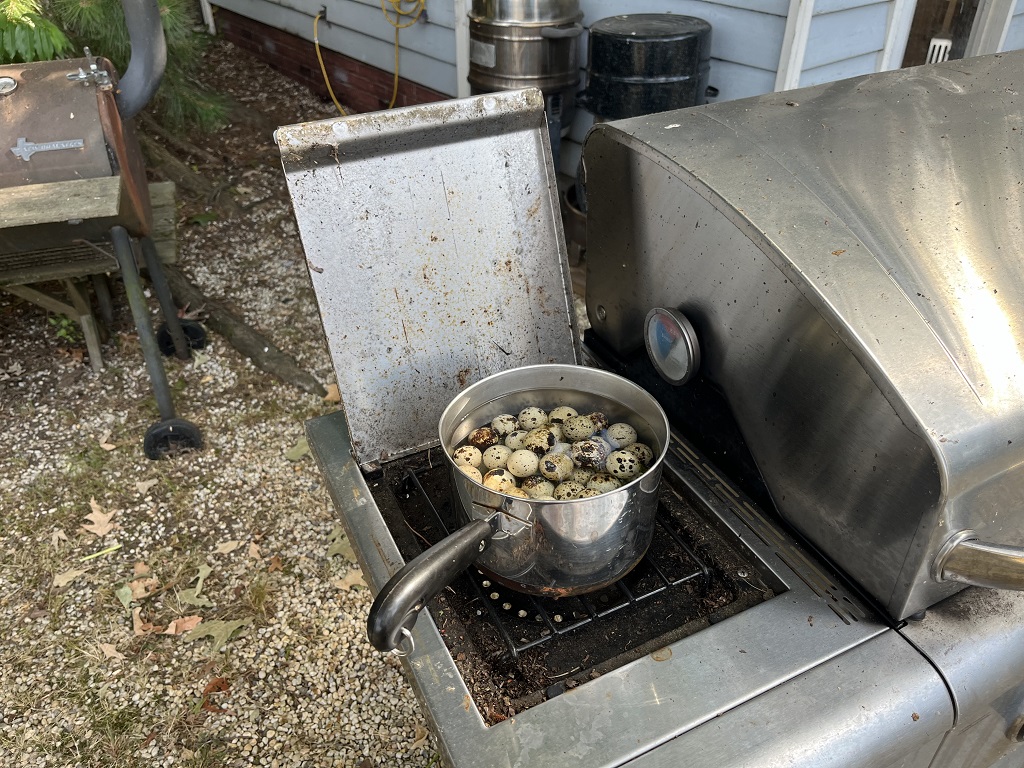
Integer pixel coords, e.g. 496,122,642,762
214,0,456,95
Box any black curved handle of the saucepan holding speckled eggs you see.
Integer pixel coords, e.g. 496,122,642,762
367,515,499,651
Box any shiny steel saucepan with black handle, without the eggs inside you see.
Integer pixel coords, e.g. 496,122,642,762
368,366,669,650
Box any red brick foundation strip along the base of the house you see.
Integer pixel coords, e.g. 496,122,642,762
214,7,450,112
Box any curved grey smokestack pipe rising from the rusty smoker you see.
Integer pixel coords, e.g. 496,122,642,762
115,0,167,121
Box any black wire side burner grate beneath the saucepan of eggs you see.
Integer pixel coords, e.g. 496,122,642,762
396,467,711,658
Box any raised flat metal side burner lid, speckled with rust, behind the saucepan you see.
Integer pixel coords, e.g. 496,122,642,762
276,89,579,475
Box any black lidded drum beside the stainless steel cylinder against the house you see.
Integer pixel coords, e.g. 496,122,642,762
579,13,711,120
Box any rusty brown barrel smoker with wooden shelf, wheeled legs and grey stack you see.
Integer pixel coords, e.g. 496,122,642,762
0,0,205,459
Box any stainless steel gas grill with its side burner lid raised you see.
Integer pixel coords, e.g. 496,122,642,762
278,54,1024,768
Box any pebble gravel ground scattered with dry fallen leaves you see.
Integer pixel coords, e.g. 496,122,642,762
0,42,436,768
